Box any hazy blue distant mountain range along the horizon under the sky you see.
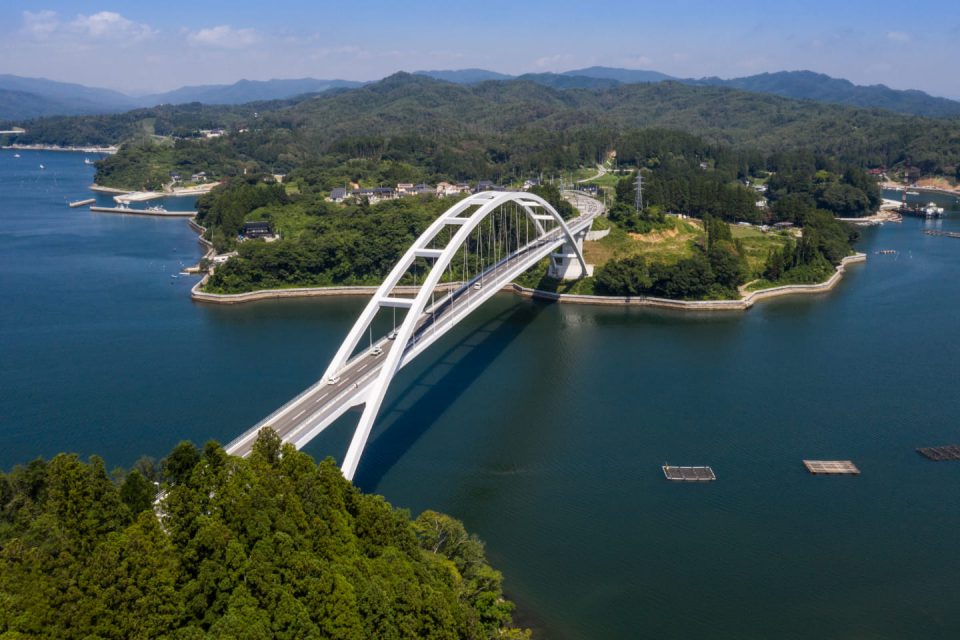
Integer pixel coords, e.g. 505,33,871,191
0,67,960,121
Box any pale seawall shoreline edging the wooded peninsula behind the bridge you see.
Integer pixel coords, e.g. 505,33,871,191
190,251,867,311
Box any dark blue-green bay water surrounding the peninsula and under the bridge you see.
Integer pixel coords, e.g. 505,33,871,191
0,152,960,638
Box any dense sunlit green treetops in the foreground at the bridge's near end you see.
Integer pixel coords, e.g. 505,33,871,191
0,431,528,640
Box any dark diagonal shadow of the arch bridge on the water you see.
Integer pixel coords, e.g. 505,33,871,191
354,300,550,490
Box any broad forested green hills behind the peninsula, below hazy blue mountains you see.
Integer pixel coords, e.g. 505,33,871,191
7,74,960,184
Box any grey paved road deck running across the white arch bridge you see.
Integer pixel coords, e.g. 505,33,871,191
227,192,603,456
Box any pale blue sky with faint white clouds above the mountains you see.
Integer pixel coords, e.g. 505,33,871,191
0,0,960,99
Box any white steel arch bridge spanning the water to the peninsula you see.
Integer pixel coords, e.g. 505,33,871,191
226,191,603,480
